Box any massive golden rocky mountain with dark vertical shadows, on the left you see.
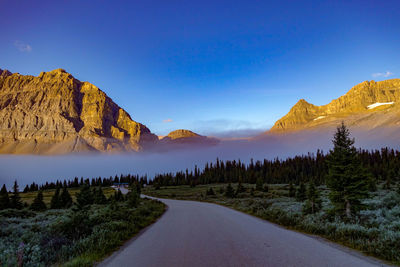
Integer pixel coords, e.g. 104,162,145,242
0,69,158,154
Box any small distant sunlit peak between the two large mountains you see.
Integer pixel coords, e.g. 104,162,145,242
160,129,218,145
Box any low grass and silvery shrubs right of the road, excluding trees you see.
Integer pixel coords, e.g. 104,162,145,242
143,184,400,264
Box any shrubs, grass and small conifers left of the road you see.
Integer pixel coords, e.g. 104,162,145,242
0,179,165,266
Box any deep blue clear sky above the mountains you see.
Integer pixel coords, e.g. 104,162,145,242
0,0,400,136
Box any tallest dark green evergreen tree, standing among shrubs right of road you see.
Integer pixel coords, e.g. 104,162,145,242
327,123,369,218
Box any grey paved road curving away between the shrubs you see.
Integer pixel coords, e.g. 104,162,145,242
100,199,388,267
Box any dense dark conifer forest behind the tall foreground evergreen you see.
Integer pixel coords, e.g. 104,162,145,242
149,148,400,191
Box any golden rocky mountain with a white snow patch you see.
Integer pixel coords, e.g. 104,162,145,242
270,79,400,133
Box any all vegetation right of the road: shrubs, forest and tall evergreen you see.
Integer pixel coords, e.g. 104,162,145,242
144,124,400,264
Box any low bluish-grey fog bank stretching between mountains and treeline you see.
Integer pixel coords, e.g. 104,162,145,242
0,129,399,190
